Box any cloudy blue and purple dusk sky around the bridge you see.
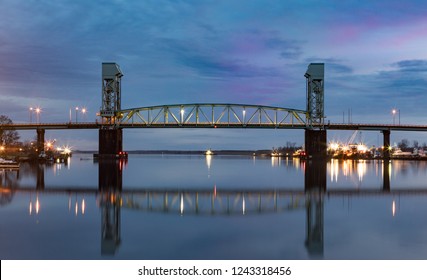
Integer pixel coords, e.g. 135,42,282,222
0,0,427,150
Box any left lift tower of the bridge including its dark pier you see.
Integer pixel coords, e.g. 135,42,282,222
99,62,123,157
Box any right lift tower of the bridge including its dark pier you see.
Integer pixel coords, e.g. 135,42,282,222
304,63,327,159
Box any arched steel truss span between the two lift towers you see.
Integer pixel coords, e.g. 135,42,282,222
117,103,307,128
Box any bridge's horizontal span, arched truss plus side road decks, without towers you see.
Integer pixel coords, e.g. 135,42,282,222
4,103,427,131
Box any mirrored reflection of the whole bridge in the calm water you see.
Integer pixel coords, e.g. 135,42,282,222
0,160,414,257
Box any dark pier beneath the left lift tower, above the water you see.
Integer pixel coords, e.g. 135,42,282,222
99,128,123,158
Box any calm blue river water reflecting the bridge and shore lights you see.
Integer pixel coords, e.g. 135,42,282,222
0,154,427,260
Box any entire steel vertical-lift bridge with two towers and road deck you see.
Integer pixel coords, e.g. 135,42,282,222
0,63,427,159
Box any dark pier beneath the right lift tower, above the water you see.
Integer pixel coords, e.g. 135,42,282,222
305,129,327,160
